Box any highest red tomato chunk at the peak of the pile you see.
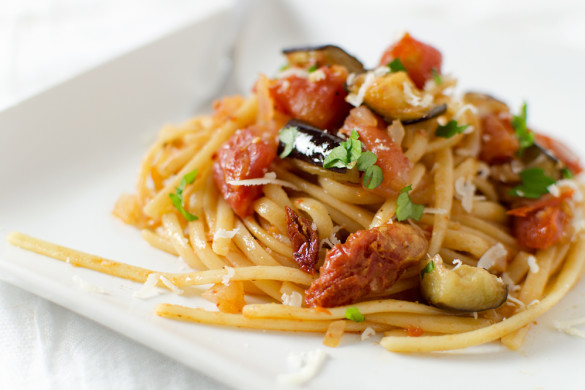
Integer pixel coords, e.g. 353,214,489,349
380,33,443,89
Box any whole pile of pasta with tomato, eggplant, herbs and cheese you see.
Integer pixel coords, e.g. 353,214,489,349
9,34,585,352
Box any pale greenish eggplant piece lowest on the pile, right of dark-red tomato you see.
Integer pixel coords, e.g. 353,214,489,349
420,256,508,312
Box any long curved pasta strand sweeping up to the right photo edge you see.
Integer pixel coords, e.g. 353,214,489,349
380,236,585,352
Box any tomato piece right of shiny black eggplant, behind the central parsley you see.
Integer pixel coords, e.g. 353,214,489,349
341,106,412,195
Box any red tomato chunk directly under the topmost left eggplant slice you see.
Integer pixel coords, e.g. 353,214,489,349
270,65,351,133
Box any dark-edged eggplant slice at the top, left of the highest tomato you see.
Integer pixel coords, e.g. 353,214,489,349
282,45,365,73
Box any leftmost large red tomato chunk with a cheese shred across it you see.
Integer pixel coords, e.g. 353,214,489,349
213,125,277,218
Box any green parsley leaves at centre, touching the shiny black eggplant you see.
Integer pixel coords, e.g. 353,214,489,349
323,130,384,190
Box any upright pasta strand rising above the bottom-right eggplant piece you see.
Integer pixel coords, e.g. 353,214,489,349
428,148,457,256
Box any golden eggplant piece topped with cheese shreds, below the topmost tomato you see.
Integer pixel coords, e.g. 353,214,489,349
346,71,447,125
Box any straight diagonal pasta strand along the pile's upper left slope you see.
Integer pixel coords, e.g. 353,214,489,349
144,96,258,218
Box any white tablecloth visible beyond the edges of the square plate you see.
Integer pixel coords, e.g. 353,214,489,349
0,0,585,389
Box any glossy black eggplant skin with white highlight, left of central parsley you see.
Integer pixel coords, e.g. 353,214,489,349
278,119,347,173
